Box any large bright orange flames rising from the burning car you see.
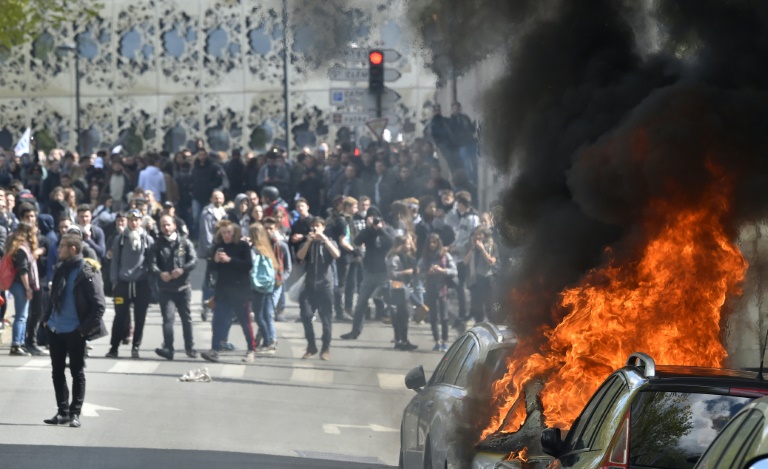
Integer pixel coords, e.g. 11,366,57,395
481,180,747,439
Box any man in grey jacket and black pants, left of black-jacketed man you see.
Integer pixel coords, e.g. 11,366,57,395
107,209,154,358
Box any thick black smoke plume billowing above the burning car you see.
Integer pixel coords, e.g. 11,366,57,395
414,0,768,460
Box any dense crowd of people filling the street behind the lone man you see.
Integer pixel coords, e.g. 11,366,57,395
0,104,499,361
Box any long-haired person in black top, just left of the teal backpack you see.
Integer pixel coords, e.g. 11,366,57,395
201,220,256,362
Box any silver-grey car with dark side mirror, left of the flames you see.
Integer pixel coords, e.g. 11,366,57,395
400,323,516,469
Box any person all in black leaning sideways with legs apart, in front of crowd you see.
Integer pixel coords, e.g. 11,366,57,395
341,208,393,340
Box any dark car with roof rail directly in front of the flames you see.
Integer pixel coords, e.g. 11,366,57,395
473,353,768,469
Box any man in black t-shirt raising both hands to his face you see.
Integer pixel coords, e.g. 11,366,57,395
296,217,340,361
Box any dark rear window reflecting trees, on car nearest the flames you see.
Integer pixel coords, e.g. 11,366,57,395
629,391,751,469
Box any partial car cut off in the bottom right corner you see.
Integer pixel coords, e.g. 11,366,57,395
696,397,768,469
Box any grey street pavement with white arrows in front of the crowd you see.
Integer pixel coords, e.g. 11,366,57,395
0,268,455,468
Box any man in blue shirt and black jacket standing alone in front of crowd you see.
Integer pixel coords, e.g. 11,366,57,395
43,235,107,428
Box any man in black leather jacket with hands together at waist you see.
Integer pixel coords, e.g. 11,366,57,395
149,215,197,360
